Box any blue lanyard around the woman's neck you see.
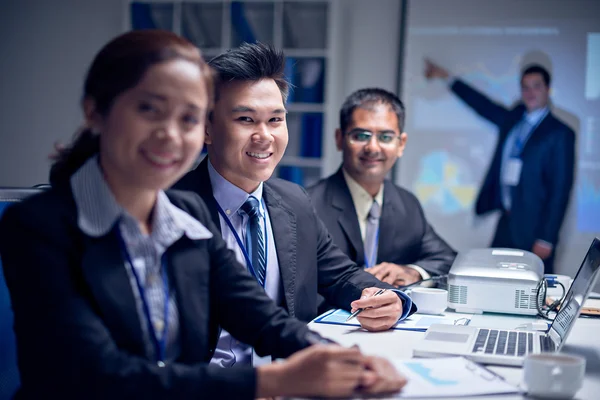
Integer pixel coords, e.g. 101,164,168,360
118,233,169,367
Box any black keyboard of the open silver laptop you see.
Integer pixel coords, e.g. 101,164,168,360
472,329,536,356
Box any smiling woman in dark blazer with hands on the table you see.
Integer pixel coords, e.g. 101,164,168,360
0,31,404,399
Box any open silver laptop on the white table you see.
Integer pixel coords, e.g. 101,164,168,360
413,238,600,366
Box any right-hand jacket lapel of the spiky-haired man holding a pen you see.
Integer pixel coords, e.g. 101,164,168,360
263,182,298,316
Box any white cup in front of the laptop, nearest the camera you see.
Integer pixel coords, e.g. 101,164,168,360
523,353,585,399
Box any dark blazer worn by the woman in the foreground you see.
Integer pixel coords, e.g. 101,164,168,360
0,183,308,399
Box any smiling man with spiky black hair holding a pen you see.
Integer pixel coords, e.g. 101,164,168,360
175,44,415,367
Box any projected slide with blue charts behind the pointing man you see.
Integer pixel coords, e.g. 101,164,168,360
399,0,600,247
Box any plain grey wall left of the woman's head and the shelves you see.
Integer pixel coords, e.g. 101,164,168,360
0,0,124,186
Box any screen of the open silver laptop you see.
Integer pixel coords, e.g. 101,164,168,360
549,238,600,344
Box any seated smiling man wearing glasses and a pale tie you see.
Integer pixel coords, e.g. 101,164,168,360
308,89,456,294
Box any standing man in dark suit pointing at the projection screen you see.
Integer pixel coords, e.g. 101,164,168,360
425,61,575,273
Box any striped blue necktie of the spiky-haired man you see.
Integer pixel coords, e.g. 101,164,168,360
240,196,267,286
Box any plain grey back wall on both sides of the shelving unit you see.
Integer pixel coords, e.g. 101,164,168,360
0,0,400,186
